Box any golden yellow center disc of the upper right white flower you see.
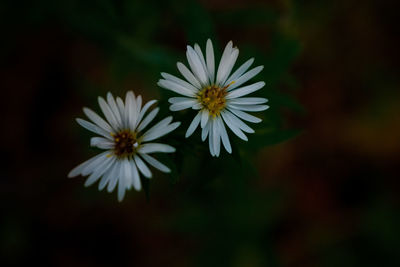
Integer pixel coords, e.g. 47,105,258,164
198,85,227,117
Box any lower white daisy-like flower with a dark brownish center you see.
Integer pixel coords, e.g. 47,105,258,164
68,91,180,201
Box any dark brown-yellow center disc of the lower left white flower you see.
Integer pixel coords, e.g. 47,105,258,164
113,130,138,157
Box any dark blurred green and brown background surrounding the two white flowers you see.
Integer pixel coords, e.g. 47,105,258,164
0,0,400,267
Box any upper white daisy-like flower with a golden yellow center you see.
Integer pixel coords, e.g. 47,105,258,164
158,39,269,157
